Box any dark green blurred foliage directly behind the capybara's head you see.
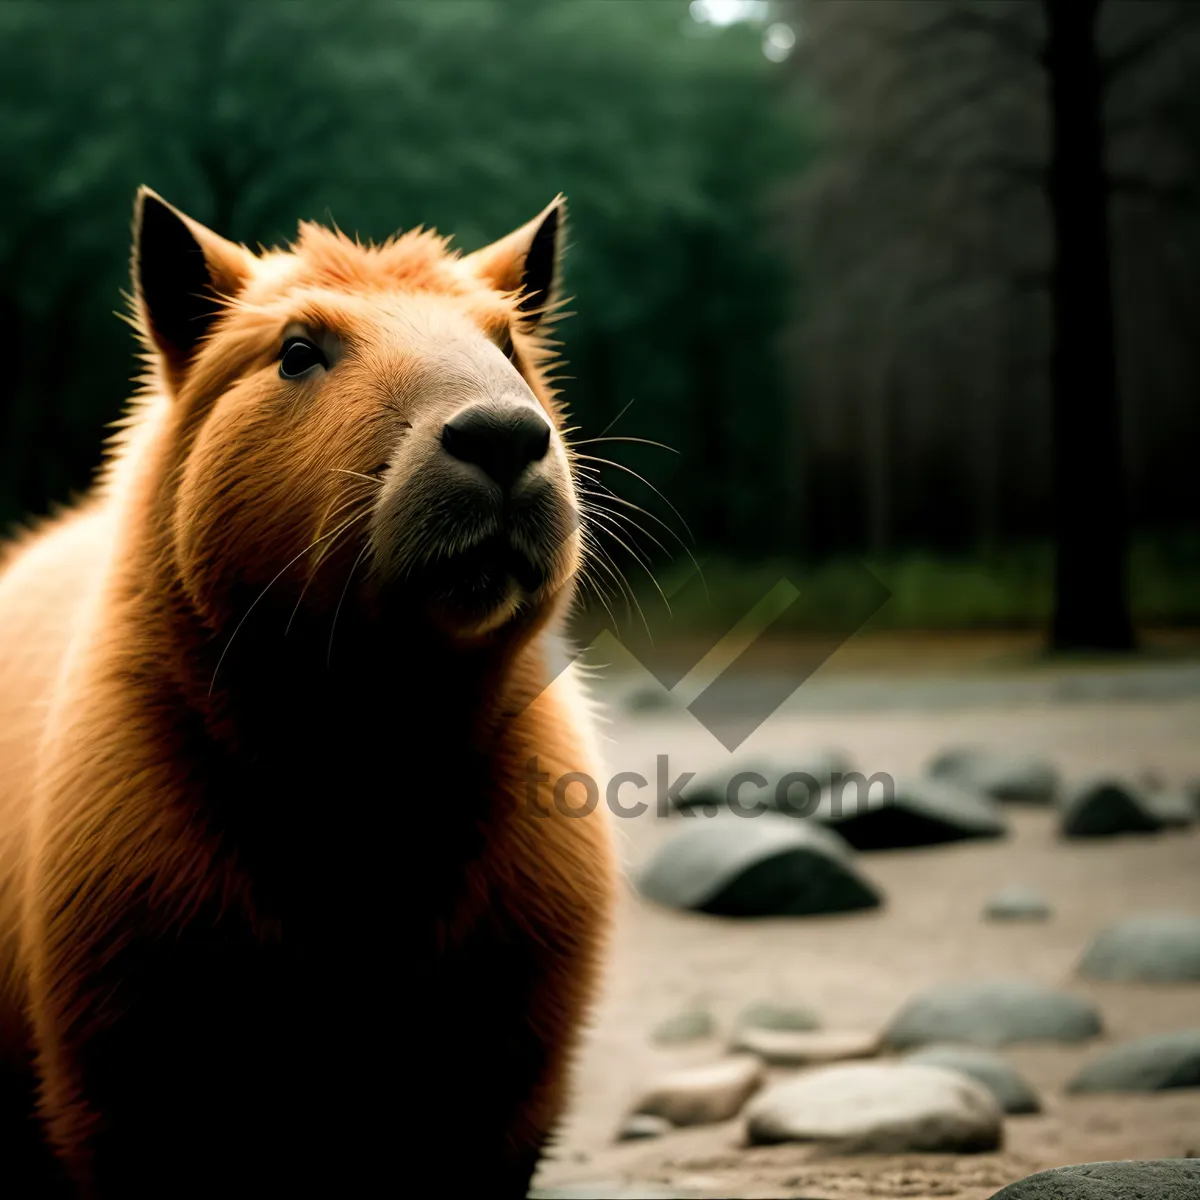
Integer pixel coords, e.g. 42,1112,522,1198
0,0,805,548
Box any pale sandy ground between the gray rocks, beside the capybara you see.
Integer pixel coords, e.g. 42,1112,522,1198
536,695,1200,1200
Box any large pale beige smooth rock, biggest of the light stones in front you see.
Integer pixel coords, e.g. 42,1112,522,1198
746,1063,1003,1154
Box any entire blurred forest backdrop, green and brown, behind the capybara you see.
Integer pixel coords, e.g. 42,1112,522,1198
0,0,1200,648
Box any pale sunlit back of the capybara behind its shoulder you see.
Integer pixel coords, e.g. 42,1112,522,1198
0,503,112,1061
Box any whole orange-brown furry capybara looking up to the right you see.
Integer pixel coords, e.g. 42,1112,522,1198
0,190,613,1200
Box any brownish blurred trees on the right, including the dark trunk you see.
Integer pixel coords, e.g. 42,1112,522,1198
790,0,1200,649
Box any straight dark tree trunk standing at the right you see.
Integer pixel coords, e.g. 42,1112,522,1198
1045,0,1134,650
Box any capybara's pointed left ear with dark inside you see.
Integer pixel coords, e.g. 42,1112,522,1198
133,187,250,388
